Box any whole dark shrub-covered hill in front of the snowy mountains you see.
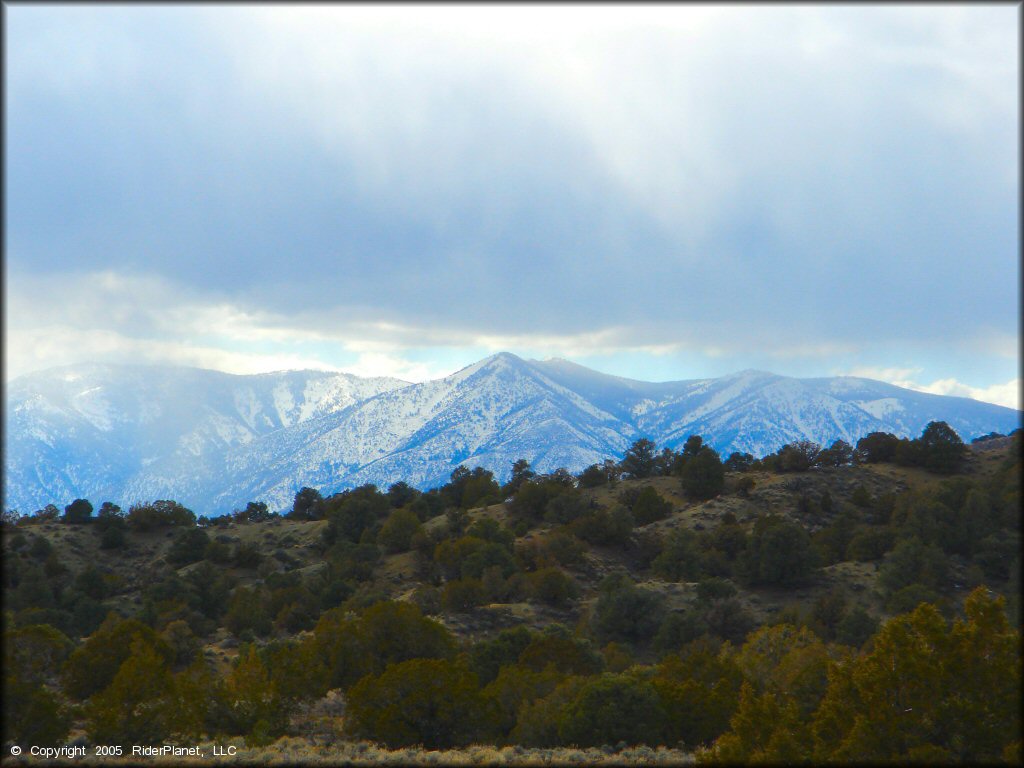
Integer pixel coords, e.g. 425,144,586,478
3,423,1021,762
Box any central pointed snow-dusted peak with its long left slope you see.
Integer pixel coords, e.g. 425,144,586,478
193,353,633,514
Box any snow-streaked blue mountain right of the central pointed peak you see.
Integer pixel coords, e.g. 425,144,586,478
536,359,1021,457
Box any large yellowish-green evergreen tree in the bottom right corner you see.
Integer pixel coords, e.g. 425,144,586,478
813,588,1021,763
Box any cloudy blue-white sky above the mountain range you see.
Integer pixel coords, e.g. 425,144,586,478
4,4,1021,408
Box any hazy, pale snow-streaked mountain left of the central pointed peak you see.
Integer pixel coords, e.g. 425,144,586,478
4,365,408,512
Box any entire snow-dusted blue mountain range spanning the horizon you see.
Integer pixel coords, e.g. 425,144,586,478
5,352,1021,514
